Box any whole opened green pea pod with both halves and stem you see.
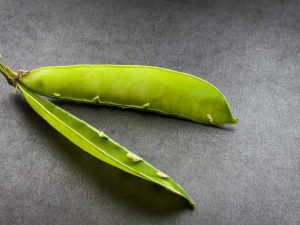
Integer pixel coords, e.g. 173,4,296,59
0,59,238,206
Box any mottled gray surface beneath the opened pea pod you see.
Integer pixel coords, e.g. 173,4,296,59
0,0,300,225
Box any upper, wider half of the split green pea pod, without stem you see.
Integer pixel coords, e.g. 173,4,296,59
15,65,238,125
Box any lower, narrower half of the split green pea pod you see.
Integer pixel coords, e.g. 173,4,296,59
17,83,195,207
